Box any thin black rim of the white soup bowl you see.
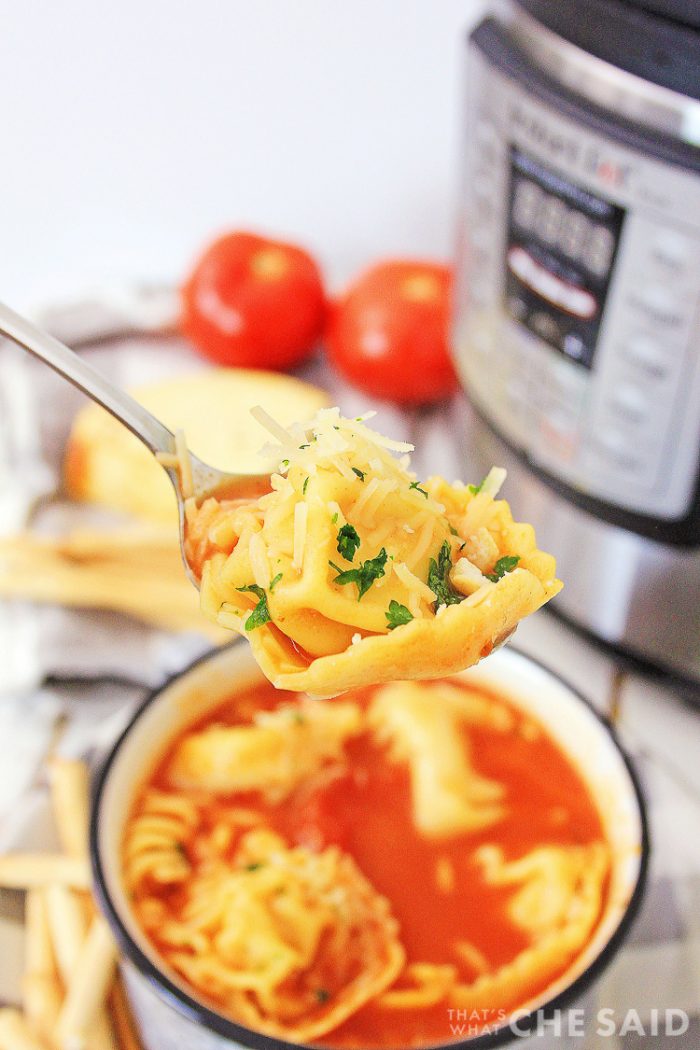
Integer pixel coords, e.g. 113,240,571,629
89,639,651,1050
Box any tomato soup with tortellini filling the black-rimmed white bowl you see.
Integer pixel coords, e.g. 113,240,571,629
123,679,610,1050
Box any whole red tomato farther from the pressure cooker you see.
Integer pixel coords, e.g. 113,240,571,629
181,232,325,369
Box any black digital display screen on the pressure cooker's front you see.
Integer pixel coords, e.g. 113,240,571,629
505,146,625,369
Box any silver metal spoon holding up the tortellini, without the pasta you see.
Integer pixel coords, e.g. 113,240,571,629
0,303,270,587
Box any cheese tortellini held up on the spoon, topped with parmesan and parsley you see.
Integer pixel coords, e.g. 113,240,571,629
187,408,560,696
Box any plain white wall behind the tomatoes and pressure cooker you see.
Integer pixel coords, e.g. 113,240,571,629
0,0,484,308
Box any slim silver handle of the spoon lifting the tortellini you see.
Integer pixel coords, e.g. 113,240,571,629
0,302,175,453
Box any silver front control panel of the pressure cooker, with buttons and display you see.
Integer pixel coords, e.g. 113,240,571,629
455,40,700,522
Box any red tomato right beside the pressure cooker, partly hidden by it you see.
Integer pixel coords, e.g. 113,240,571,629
325,259,458,404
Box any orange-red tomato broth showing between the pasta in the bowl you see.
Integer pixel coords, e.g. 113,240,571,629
128,680,608,1050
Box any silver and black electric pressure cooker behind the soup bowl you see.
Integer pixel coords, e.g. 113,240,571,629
454,0,700,681
